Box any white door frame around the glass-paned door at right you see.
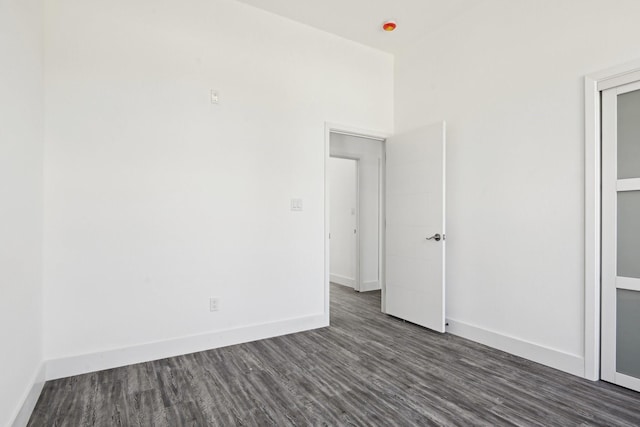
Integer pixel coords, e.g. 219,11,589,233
584,56,640,381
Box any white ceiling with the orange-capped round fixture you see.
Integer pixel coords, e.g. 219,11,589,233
238,0,478,53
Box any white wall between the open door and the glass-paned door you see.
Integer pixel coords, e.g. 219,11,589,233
395,0,640,374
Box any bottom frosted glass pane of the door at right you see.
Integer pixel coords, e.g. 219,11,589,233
616,289,640,378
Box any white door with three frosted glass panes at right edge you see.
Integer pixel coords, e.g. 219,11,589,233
601,82,640,391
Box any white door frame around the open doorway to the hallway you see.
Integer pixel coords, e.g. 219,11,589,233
324,122,390,325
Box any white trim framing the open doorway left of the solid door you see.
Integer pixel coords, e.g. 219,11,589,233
324,122,389,325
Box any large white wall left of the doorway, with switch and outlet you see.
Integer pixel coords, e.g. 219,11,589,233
45,0,393,375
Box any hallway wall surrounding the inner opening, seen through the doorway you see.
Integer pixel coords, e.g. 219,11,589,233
330,133,383,291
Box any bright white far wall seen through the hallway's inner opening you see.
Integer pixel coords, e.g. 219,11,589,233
327,157,358,288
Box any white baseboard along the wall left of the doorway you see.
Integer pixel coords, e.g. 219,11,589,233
46,314,329,380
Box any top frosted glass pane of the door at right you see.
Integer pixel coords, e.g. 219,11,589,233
618,90,640,179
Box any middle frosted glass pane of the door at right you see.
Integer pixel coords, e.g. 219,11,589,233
617,191,640,280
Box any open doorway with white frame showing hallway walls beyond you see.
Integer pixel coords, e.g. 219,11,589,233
325,125,386,323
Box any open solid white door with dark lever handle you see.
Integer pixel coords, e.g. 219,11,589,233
385,122,446,332
